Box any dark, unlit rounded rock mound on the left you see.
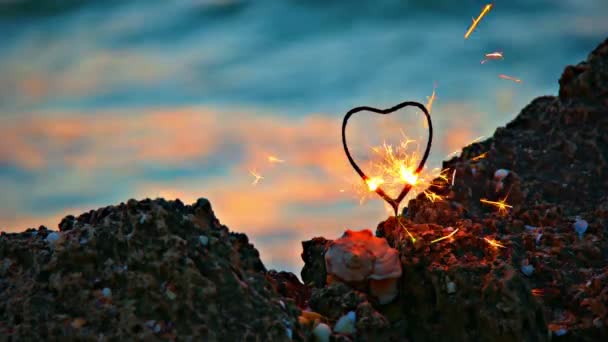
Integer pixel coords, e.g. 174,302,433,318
0,199,303,341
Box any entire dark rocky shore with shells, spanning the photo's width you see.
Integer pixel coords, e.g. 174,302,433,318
0,40,608,342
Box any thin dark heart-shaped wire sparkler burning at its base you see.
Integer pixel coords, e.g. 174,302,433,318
342,101,433,216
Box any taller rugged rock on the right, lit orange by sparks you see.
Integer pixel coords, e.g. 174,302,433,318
302,40,608,342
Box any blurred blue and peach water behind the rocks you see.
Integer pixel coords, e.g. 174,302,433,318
0,0,608,270
